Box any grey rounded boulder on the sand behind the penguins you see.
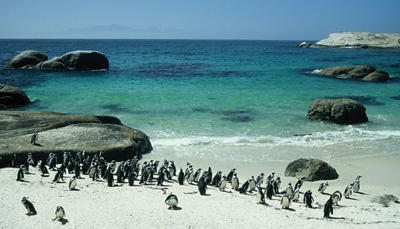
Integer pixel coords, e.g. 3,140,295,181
285,158,339,181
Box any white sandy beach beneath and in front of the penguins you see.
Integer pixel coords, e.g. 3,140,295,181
0,156,400,228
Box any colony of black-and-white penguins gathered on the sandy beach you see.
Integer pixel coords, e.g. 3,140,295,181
9,151,361,219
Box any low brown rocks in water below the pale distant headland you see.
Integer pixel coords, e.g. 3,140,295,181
316,65,390,82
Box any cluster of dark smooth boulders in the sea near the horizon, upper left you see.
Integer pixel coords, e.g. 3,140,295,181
6,50,109,71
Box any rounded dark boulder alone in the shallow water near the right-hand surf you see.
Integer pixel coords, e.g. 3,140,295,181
307,99,368,124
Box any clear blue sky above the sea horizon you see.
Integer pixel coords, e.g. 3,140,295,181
0,0,400,40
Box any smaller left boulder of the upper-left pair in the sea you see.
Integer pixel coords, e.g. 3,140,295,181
6,50,48,69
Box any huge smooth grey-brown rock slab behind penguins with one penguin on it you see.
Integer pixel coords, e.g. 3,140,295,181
0,111,152,166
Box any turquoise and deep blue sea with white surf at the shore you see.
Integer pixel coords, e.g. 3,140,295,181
0,40,400,174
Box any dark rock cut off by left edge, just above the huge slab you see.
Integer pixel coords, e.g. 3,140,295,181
0,84,31,109
